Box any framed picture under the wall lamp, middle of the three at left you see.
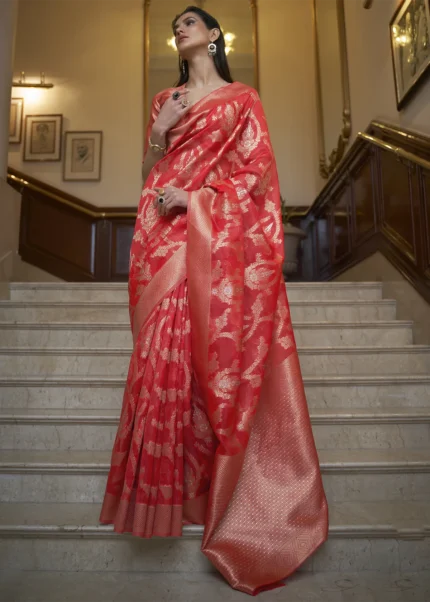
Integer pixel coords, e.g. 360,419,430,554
24,115,63,161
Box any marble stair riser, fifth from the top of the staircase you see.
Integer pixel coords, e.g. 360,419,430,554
0,382,430,412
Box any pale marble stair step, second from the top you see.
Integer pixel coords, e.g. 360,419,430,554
0,299,396,323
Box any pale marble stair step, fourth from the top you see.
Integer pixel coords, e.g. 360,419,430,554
0,345,430,376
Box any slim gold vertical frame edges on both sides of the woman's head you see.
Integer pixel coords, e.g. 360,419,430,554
143,0,260,124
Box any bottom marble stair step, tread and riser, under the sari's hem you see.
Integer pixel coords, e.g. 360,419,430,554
0,502,430,572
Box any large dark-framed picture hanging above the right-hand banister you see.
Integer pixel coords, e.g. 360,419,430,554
390,0,430,111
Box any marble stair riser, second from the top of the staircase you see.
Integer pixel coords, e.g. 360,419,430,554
0,303,396,324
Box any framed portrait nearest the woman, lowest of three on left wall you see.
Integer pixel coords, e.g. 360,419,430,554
63,132,103,182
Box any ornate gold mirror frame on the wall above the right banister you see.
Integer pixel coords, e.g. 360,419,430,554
312,0,352,179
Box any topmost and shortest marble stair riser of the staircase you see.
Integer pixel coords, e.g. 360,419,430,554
11,284,382,303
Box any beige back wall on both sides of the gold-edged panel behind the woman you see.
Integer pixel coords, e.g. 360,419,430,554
9,0,317,206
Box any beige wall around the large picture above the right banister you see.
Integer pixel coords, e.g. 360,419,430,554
345,0,430,136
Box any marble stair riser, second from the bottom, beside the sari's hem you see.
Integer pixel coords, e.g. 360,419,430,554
0,473,430,504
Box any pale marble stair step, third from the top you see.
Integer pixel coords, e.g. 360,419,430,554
0,320,413,349
